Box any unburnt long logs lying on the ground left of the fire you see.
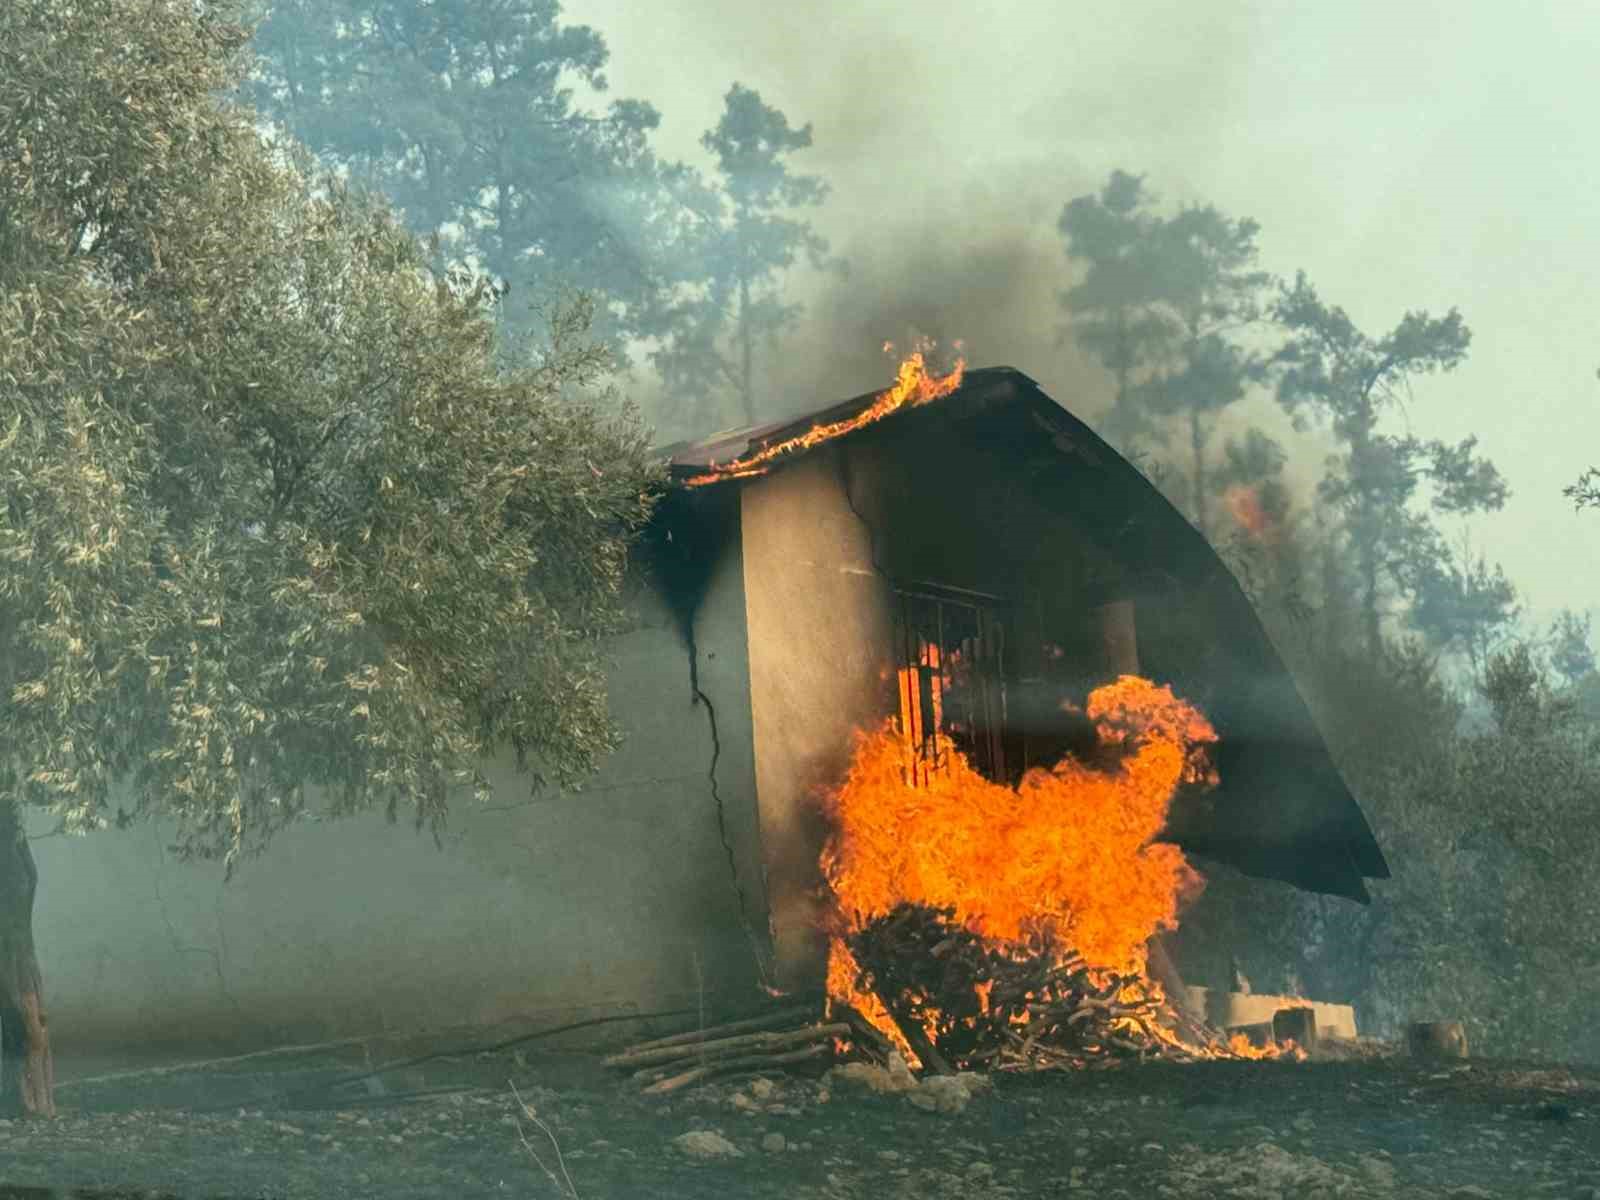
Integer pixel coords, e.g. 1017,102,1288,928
603,997,851,1096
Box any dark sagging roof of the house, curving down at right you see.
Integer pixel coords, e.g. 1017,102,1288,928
662,368,1389,902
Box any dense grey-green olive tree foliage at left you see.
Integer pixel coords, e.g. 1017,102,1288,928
0,0,653,870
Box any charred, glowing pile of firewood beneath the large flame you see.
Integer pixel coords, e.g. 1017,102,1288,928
846,904,1214,1074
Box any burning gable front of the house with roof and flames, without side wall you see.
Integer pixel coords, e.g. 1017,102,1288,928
654,357,1389,1062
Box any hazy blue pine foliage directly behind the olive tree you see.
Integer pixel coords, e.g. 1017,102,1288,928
245,0,682,349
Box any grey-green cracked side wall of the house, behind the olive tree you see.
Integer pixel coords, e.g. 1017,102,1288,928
34,544,765,1059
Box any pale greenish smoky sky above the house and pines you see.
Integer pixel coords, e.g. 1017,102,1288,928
565,0,1600,633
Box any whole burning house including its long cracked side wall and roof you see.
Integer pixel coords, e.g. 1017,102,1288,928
35,358,1387,1050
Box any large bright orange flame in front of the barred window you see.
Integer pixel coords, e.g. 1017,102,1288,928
822,675,1216,979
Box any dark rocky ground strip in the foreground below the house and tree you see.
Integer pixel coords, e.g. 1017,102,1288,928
0,1051,1600,1200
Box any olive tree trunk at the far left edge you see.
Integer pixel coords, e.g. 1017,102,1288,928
0,800,56,1117
